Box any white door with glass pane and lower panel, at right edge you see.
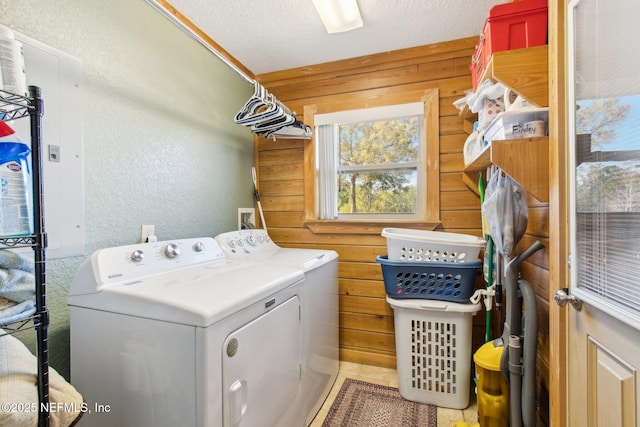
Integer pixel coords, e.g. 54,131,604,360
557,0,640,427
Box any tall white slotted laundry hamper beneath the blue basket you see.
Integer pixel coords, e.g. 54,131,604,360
387,297,480,409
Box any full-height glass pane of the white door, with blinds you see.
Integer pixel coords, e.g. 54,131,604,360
570,0,640,318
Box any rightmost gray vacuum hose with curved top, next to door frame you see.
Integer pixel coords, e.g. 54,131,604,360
518,280,538,427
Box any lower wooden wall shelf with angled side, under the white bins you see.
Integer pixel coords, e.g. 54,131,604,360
462,136,549,202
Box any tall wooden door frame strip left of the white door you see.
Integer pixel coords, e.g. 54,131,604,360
548,0,569,426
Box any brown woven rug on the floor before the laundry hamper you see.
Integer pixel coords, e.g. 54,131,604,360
322,378,438,427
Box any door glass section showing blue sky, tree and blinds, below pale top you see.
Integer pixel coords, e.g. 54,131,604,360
575,96,640,310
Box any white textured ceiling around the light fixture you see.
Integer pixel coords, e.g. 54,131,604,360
162,0,506,74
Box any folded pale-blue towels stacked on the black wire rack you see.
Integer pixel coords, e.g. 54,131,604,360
0,249,35,302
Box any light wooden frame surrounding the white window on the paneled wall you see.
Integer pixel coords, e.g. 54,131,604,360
303,87,440,234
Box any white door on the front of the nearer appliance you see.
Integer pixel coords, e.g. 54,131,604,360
222,296,302,427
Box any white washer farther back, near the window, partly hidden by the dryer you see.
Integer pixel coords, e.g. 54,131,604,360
216,229,339,425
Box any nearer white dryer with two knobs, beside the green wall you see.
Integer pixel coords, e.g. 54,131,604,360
68,237,306,427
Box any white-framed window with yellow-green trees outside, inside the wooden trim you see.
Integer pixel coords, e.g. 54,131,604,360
314,102,426,219
